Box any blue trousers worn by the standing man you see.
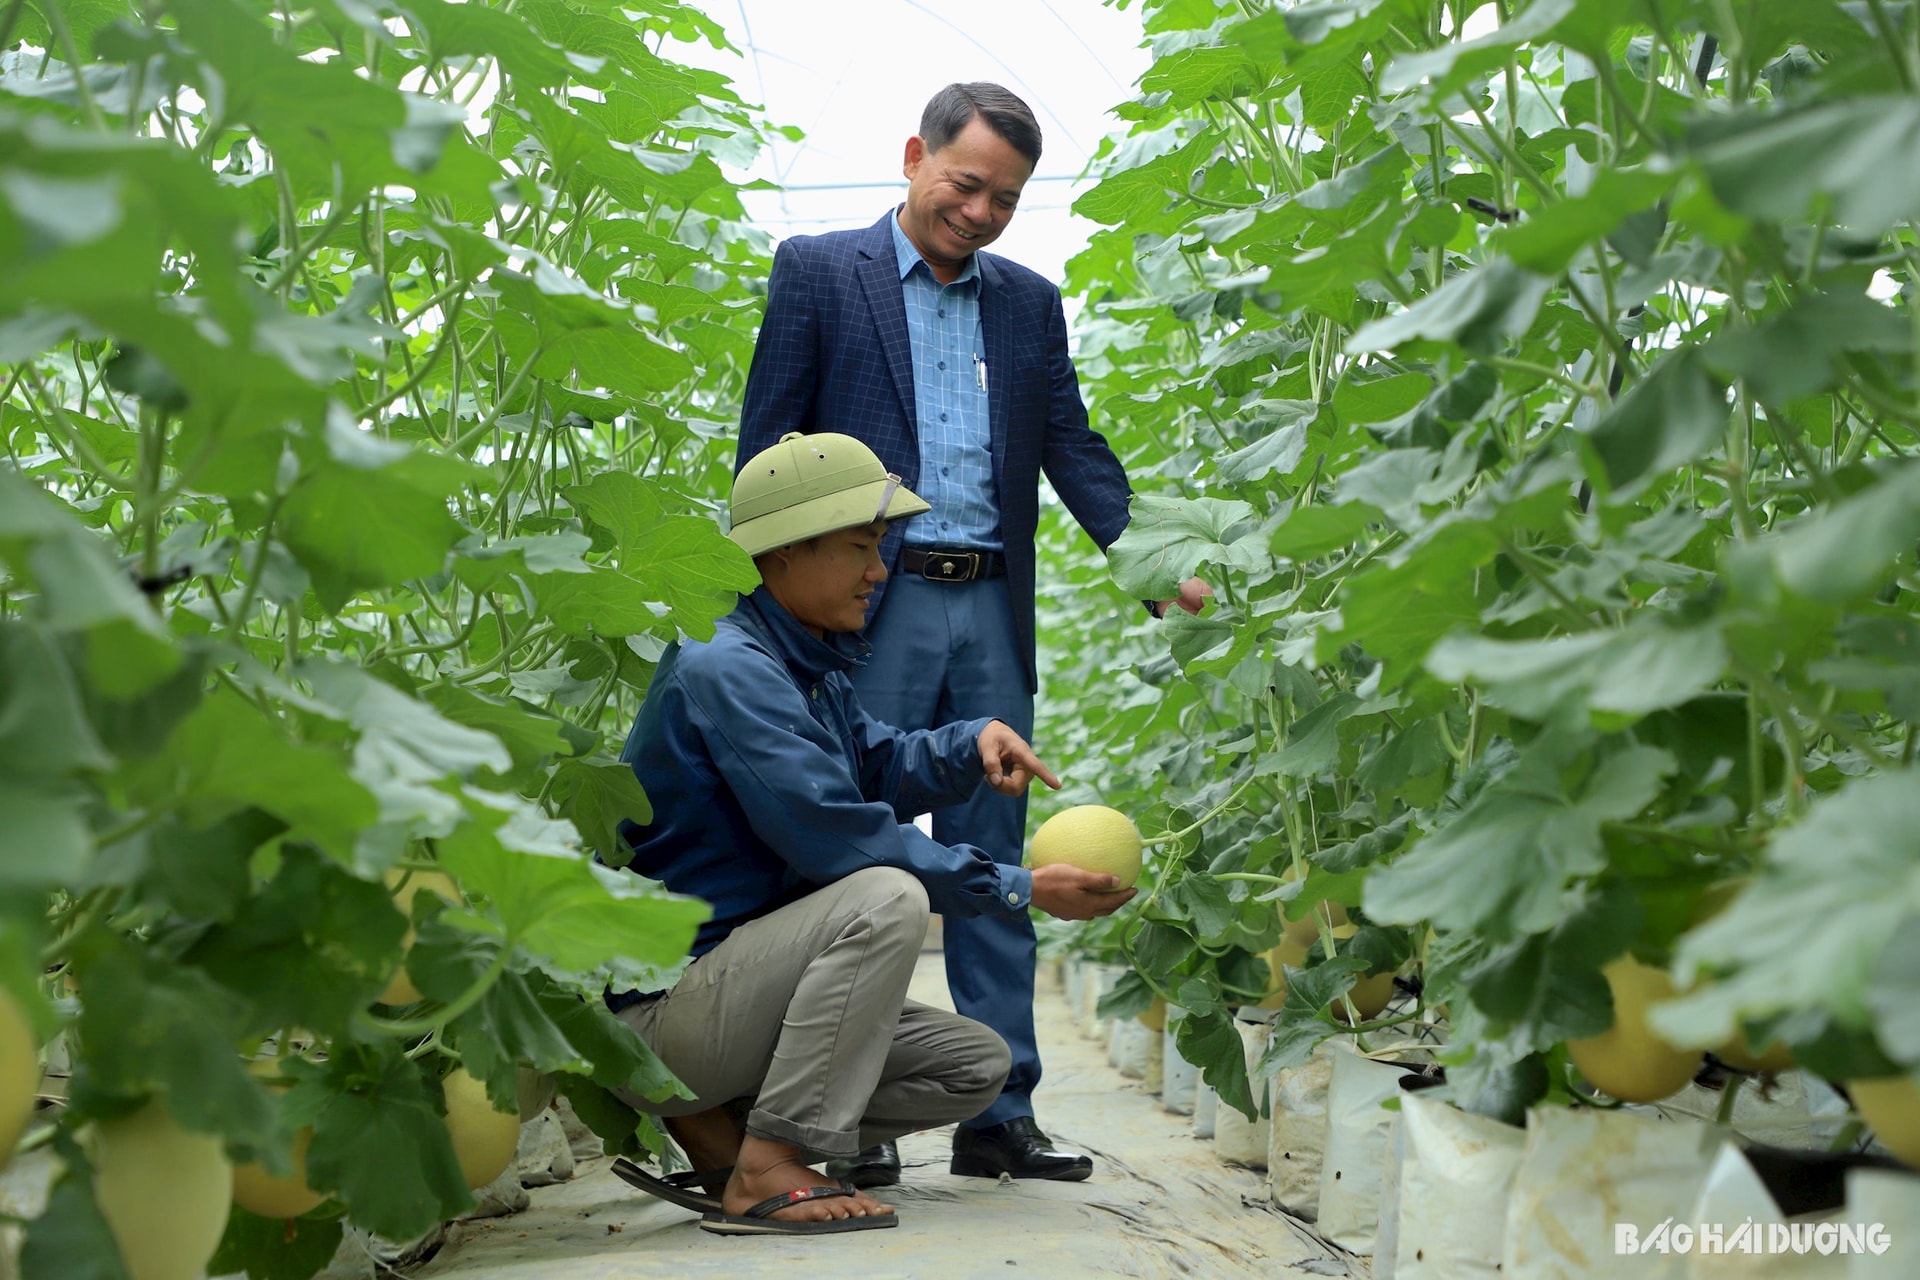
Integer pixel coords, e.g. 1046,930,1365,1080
852,574,1044,1128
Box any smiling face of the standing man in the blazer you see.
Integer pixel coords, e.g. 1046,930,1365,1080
900,115,1033,278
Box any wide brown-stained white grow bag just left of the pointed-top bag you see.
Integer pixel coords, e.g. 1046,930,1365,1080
1501,1107,1724,1280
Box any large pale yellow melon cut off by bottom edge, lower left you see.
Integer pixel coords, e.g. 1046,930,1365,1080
88,1098,234,1280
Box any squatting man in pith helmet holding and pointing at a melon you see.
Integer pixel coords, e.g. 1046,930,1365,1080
609,432,1133,1234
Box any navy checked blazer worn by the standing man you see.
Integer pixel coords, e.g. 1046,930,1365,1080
733,209,1131,691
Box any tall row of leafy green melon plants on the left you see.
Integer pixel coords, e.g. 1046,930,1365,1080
0,0,787,1280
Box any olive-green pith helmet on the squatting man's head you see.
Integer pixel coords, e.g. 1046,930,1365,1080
728,432,931,555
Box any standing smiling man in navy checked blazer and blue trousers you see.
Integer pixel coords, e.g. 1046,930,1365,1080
735,83,1206,1186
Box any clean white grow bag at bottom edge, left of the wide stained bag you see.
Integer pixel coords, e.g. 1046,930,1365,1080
1373,1092,1526,1280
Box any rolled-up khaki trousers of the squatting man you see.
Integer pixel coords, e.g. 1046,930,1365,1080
620,867,1010,1161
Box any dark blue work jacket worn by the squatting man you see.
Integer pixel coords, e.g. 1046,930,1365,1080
620,587,1033,956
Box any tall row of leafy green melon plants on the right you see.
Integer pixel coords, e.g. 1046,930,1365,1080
1037,0,1920,1119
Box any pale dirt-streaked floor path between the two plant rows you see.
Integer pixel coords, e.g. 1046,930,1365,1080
417,952,1367,1280
